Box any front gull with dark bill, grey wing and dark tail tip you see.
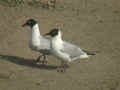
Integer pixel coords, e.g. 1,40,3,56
45,28,95,72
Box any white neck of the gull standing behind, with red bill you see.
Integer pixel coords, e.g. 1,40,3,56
29,24,40,47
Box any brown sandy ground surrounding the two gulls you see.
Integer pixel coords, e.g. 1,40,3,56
0,0,120,90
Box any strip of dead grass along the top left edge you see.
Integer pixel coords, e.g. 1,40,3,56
0,0,56,8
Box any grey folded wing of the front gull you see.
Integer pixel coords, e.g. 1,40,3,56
62,41,86,60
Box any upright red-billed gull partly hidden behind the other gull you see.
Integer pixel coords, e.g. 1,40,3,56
22,19,50,65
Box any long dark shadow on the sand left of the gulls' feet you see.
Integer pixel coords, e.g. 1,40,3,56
0,54,57,70
